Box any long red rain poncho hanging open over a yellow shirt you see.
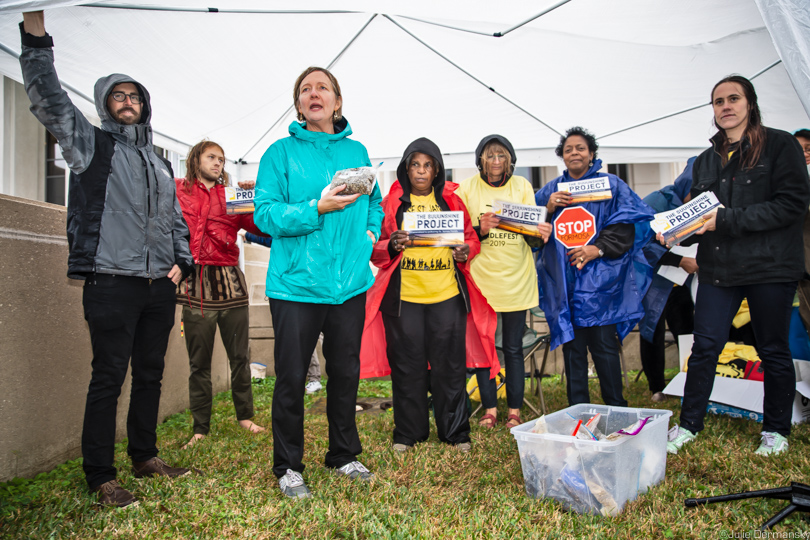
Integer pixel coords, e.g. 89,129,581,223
360,182,501,379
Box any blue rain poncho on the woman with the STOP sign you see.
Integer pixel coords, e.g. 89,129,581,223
535,159,653,349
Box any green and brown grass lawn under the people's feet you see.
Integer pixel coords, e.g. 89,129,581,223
0,373,810,539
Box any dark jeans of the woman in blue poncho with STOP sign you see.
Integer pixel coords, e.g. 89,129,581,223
563,324,627,407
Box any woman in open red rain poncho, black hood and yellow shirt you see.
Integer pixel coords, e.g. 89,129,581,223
360,138,499,452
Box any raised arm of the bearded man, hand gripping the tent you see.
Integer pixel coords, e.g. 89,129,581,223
20,11,95,173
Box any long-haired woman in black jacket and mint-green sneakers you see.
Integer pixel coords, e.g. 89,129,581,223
667,75,810,455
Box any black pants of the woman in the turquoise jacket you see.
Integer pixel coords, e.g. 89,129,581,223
270,293,366,478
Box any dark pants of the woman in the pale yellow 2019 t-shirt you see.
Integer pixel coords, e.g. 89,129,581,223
475,309,526,409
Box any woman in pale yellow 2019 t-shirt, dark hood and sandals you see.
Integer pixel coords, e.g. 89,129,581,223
458,135,551,428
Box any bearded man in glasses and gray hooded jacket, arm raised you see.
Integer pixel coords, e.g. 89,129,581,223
20,11,193,507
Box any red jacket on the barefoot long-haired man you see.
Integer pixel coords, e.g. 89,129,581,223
174,178,267,266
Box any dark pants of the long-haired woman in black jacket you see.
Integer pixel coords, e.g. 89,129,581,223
681,281,796,437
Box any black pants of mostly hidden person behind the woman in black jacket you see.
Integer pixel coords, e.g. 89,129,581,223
639,287,695,394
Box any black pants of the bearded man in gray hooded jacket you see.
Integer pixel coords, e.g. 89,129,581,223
82,274,175,489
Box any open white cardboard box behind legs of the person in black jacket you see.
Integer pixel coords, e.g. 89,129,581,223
664,335,810,424
